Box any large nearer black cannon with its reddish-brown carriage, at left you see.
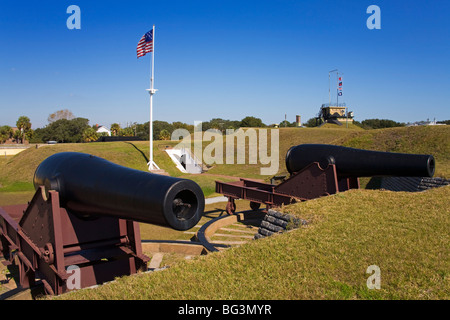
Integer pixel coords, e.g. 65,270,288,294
0,152,205,294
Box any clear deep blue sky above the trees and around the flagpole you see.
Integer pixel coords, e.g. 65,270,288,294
0,0,450,129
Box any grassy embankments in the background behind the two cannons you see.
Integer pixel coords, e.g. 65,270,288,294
0,124,450,205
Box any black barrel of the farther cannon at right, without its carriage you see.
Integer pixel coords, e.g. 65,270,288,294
286,144,435,178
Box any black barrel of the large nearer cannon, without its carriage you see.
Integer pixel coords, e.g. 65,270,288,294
33,152,205,230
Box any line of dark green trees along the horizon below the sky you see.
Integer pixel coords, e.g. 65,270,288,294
0,109,450,143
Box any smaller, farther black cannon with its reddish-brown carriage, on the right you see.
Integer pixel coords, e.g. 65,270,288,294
216,144,435,214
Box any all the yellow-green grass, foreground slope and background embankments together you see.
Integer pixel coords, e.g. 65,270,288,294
0,125,450,299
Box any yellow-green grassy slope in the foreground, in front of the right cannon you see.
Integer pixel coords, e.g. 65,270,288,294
60,187,450,299
